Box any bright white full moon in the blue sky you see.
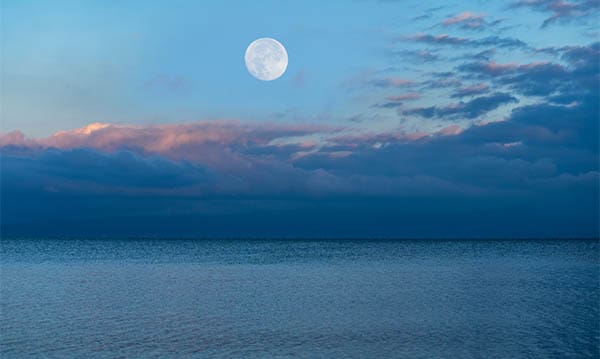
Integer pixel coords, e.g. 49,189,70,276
244,37,287,81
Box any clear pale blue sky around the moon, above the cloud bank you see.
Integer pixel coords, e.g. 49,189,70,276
2,1,592,136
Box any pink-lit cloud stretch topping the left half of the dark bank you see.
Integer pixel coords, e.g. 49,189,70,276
0,120,340,170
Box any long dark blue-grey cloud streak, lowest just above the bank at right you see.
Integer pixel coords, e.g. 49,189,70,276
402,92,518,119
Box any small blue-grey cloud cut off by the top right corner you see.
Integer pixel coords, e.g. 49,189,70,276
512,0,600,27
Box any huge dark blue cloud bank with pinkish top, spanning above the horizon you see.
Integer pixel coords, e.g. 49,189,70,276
0,101,599,237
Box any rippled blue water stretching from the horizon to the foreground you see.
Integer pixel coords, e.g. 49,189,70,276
0,239,600,358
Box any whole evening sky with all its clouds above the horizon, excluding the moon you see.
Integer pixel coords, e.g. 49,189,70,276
0,0,600,238
